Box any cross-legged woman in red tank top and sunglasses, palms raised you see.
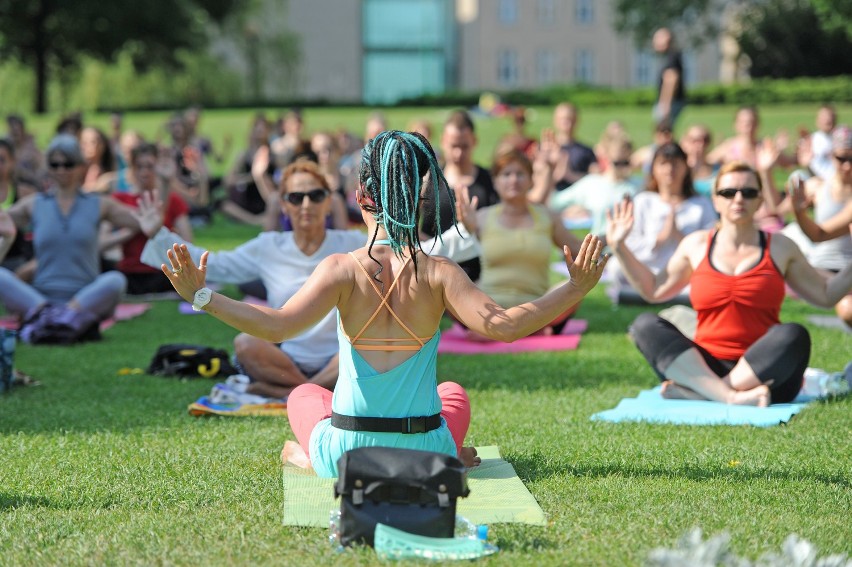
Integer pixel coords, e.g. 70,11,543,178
607,162,852,406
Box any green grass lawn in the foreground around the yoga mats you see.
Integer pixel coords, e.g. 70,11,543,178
0,211,852,565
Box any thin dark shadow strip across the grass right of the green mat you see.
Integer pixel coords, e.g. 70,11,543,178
507,454,852,489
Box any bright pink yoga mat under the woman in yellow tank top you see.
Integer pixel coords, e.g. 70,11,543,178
438,319,588,354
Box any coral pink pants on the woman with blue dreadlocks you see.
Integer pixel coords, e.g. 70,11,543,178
287,382,470,457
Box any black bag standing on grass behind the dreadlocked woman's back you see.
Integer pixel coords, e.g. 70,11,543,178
334,447,470,546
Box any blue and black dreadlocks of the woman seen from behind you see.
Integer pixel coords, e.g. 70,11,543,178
360,130,456,280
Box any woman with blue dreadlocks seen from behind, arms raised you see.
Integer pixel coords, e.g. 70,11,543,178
162,130,607,477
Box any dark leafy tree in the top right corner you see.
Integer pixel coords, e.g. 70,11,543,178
737,0,852,78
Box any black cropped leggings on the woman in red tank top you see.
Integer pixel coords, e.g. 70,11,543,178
630,313,811,404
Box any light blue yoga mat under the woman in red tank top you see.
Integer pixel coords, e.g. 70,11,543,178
592,386,807,427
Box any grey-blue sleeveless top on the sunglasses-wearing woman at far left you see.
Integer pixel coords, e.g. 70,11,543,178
32,192,101,301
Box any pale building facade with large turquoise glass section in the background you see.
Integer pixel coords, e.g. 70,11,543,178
264,0,721,104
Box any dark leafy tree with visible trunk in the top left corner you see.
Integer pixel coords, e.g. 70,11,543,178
0,0,241,112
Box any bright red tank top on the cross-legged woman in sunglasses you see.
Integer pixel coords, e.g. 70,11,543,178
689,232,785,360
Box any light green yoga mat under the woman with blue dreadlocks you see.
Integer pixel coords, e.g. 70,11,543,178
284,447,547,528
